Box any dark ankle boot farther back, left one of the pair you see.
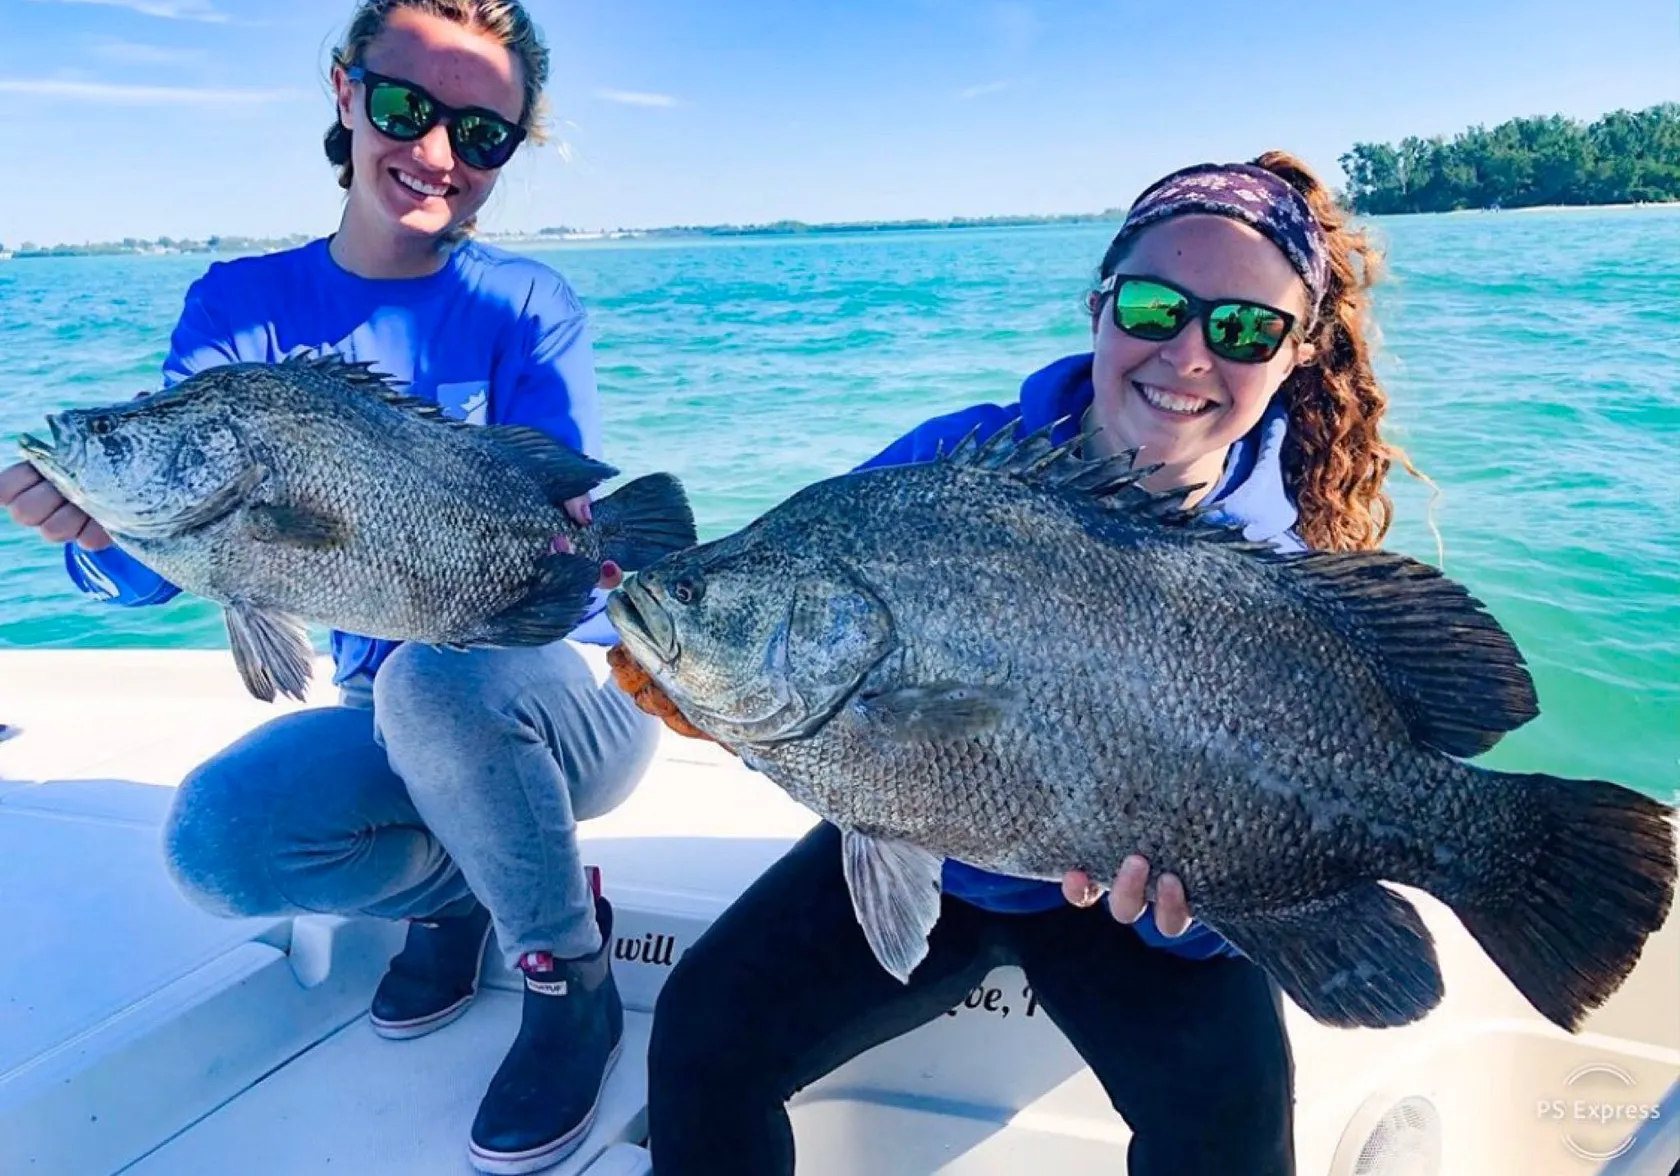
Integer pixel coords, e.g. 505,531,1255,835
368,897,491,1040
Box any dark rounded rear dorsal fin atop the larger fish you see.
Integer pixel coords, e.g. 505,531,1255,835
1273,551,1541,756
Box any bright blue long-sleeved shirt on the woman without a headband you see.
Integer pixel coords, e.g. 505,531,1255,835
64,239,617,684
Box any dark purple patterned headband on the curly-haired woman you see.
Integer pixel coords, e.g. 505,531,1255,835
1114,163,1331,321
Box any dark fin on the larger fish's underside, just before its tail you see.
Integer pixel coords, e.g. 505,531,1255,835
1198,882,1441,1028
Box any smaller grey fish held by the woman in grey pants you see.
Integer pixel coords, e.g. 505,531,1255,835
22,356,696,699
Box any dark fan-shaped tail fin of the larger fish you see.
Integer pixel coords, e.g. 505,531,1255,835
1450,773,1675,1032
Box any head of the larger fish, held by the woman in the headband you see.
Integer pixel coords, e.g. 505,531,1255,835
606,529,895,746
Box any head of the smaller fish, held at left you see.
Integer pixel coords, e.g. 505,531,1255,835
18,393,249,533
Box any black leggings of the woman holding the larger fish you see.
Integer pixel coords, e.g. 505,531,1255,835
648,823,1295,1176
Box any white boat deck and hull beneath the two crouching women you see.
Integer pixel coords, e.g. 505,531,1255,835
0,650,1680,1176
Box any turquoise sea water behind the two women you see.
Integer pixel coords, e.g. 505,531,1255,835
0,208,1680,795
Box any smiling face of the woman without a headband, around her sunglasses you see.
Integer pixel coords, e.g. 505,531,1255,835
333,7,524,237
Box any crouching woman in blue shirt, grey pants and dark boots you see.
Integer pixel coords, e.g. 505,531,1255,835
0,0,655,1173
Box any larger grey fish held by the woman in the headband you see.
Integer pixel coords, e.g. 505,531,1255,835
608,423,1675,1028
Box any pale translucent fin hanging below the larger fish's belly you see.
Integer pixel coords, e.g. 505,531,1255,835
842,828,944,983
